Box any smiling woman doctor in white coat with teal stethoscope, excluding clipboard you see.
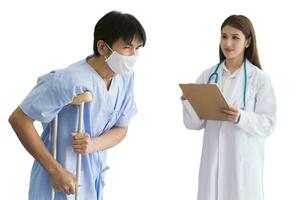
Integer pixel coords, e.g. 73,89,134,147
182,15,276,200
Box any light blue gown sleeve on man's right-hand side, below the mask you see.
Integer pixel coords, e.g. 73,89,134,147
115,73,137,127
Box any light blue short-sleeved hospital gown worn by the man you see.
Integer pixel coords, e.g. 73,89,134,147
20,56,137,200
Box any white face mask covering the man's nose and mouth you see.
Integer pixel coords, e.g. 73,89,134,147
105,44,137,75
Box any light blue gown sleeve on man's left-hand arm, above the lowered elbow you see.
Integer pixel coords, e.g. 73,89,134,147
20,71,80,123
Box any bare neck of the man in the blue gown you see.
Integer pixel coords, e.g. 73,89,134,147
87,56,116,81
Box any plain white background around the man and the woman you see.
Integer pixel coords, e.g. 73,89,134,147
0,0,300,200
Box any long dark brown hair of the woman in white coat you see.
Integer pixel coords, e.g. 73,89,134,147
219,15,262,69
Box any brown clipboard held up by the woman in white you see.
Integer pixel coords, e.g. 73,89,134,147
179,84,229,121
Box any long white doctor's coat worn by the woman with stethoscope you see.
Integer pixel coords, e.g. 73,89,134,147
182,60,276,200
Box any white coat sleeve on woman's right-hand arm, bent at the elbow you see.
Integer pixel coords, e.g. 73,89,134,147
237,73,276,137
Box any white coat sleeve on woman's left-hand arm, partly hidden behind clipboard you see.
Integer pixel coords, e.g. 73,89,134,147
181,73,206,130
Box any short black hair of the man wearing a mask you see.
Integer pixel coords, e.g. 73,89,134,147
93,11,146,56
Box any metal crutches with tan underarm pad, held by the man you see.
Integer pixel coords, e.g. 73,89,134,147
51,92,93,200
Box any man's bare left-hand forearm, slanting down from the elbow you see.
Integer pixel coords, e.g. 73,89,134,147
9,107,61,174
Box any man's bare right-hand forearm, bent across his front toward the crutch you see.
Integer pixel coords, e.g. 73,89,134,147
93,127,128,151
